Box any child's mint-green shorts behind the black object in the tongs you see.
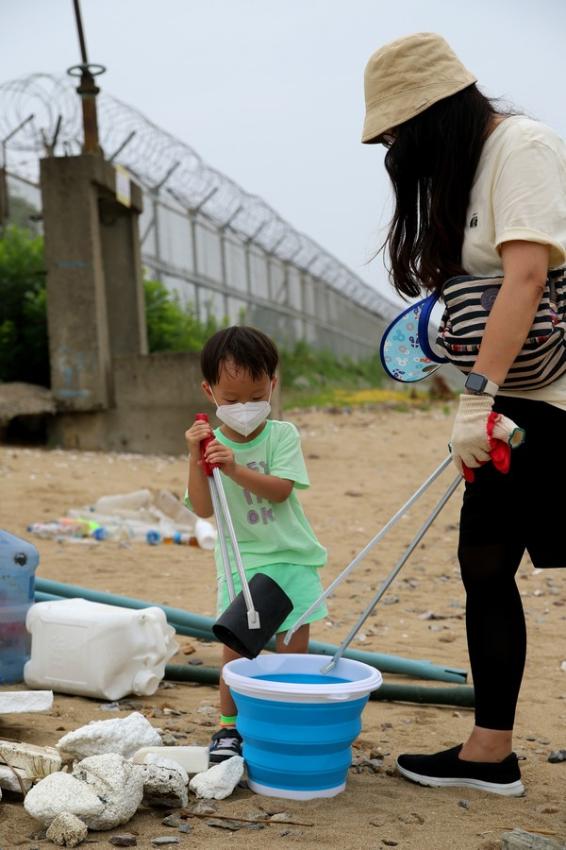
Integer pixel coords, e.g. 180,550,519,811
218,564,328,634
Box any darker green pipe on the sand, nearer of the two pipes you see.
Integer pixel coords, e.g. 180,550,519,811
165,664,474,708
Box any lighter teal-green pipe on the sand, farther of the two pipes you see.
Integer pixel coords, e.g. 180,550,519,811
35,577,467,684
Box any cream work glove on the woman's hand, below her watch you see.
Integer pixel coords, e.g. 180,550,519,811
450,393,525,474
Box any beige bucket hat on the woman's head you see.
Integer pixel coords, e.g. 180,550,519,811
362,32,477,143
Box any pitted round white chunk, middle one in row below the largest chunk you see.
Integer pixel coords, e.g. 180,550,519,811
72,753,143,829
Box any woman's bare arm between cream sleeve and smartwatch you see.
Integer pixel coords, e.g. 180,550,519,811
473,241,550,386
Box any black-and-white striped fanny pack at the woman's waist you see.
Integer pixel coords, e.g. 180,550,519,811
436,269,566,390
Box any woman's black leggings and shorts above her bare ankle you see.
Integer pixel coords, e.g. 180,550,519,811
458,396,566,729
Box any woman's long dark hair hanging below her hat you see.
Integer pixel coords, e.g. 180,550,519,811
382,85,498,297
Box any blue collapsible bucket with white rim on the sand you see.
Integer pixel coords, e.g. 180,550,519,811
223,654,382,800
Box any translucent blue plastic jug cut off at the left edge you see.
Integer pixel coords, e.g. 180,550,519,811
0,530,39,684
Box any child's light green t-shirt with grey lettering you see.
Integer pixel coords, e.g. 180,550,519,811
185,419,326,575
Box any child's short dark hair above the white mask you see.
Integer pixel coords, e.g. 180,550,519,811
200,325,279,386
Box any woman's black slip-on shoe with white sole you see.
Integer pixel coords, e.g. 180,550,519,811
397,744,525,797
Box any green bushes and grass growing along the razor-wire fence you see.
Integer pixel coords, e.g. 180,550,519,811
0,226,398,407
